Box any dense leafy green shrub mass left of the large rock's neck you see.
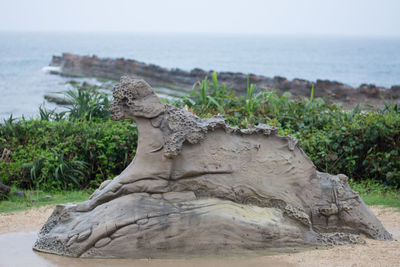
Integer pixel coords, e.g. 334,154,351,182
0,119,137,190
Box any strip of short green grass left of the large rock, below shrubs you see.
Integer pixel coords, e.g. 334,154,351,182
0,188,90,213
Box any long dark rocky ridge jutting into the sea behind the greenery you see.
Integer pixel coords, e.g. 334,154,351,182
50,53,400,107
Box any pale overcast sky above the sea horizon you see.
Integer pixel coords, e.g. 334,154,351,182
0,0,400,36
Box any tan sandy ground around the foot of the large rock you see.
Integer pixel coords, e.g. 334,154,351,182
0,206,400,267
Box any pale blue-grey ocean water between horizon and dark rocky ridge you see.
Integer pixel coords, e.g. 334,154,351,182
0,32,400,119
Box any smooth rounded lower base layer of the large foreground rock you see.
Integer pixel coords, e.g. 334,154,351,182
34,192,363,258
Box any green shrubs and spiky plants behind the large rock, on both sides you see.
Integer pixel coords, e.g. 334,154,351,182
0,76,400,213
